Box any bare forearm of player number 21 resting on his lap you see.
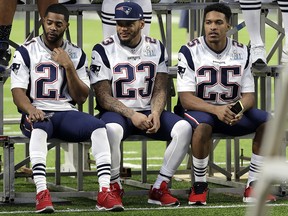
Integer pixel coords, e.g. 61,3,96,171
12,88,45,122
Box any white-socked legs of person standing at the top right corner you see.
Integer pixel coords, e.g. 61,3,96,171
220,0,288,67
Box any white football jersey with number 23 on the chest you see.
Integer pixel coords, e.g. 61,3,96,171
90,34,168,111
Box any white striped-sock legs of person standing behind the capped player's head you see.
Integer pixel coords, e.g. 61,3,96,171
101,0,152,39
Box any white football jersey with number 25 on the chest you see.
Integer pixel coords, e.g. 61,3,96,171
177,36,254,104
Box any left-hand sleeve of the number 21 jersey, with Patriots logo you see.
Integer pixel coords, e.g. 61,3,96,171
10,46,30,89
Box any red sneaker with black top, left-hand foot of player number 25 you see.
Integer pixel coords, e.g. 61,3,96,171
188,182,208,205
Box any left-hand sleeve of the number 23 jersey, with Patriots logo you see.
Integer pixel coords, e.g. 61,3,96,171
90,44,112,84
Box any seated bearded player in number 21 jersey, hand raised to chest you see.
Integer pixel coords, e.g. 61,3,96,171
10,4,123,213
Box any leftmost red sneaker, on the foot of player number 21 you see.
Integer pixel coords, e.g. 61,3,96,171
36,189,54,213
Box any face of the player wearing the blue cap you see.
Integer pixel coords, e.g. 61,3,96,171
116,20,144,47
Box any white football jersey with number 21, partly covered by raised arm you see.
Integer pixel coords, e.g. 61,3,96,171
10,36,90,111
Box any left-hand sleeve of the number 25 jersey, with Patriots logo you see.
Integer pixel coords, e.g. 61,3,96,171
177,46,196,92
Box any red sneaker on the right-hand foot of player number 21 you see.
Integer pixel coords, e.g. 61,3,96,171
96,188,124,211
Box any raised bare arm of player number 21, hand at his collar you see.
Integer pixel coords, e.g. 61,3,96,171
52,48,89,104
